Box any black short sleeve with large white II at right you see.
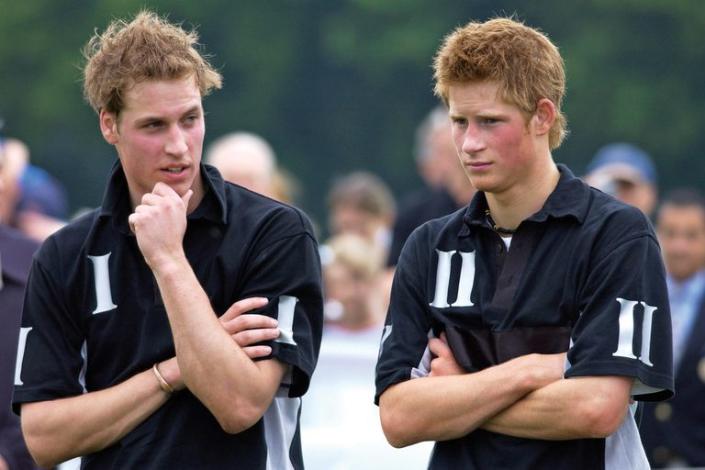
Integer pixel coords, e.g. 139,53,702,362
566,229,674,401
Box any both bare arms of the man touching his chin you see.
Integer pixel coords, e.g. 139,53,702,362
21,183,286,467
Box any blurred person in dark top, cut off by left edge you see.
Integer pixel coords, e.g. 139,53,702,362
0,129,38,470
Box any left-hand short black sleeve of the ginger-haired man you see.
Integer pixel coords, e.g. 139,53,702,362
375,229,432,404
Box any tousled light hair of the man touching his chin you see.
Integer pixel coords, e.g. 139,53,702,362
83,10,222,114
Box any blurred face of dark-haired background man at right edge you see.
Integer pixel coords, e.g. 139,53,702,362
657,204,705,281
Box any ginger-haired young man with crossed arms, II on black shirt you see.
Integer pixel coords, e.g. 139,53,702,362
376,18,673,469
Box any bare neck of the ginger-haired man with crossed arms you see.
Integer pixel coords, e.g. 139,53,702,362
486,159,560,230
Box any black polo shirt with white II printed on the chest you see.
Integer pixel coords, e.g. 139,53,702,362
376,165,673,469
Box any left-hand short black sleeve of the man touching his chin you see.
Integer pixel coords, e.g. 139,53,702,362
13,248,84,413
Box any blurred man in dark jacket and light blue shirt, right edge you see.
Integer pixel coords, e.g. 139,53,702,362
639,189,705,468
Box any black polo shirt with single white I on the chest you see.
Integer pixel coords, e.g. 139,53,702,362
14,164,322,469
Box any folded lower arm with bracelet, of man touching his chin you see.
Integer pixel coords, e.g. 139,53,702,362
21,298,279,467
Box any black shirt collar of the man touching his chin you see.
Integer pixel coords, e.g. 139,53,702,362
99,160,228,234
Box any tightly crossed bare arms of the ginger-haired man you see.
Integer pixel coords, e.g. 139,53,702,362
379,332,632,447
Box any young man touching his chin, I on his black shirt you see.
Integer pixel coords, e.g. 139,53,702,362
14,12,322,469
